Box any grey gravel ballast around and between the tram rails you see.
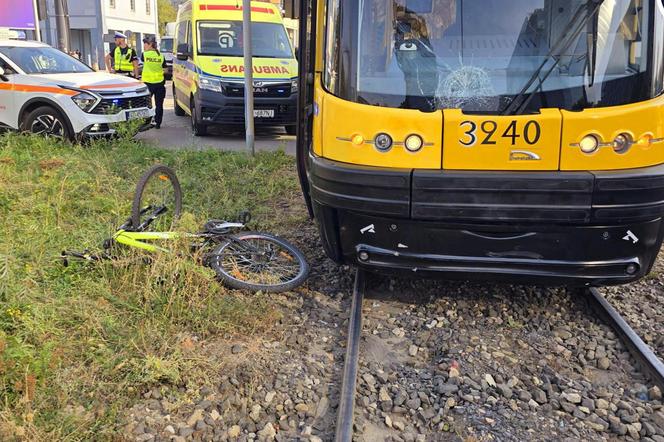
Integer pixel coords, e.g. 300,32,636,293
124,223,664,442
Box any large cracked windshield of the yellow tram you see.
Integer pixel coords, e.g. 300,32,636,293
325,0,661,113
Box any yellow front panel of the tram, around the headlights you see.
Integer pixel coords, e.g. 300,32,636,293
312,81,664,171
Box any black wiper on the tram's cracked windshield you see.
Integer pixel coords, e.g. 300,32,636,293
502,0,604,115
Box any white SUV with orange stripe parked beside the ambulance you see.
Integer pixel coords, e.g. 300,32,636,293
0,40,154,140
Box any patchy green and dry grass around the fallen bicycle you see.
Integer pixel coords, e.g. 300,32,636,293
0,134,298,440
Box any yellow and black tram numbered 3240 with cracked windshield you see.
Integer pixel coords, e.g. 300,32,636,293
298,0,664,285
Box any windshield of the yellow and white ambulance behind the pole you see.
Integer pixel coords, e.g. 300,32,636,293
198,21,293,58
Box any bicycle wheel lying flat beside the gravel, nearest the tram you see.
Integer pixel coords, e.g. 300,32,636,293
208,232,309,292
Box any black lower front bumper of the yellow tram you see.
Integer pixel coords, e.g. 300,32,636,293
309,156,664,286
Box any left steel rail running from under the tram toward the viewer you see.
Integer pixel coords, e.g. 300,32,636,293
335,269,366,442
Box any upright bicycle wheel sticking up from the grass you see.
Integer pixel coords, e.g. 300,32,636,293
131,164,182,231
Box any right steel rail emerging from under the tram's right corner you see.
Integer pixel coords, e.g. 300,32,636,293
586,288,664,391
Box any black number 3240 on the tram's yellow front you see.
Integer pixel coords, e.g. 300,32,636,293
459,120,542,147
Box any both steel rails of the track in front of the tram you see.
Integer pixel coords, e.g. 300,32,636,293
335,269,664,442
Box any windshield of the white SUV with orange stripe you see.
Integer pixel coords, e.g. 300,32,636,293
0,46,92,74
